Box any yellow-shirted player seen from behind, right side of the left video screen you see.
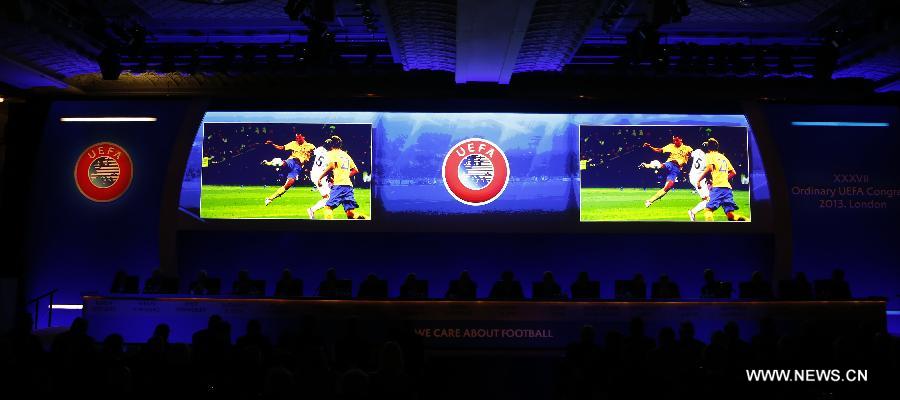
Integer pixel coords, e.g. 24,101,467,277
316,135,368,219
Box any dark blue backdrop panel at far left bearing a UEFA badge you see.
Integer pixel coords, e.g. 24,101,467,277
22,101,196,325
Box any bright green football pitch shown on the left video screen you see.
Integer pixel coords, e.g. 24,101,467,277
200,185,372,219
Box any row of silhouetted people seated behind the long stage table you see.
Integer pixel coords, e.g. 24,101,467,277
111,268,851,300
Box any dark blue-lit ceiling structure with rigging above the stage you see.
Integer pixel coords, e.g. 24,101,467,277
0,0,900,94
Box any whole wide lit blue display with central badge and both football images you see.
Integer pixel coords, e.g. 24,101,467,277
193,111,767,224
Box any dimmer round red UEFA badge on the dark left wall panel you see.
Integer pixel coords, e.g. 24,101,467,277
75,142,134,202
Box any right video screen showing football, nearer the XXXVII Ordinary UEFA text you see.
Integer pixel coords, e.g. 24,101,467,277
579,125,750,222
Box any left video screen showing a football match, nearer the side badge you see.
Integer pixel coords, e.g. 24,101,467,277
200,122,372,220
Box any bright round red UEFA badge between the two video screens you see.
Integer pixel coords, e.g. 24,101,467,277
441,138,509,206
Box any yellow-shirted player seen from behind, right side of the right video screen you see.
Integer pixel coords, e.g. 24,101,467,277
699,138,749,221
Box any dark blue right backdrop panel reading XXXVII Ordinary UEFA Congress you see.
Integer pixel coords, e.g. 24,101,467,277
766,105,900,332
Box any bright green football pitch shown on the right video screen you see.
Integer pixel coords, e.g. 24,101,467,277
581,188,750,222
